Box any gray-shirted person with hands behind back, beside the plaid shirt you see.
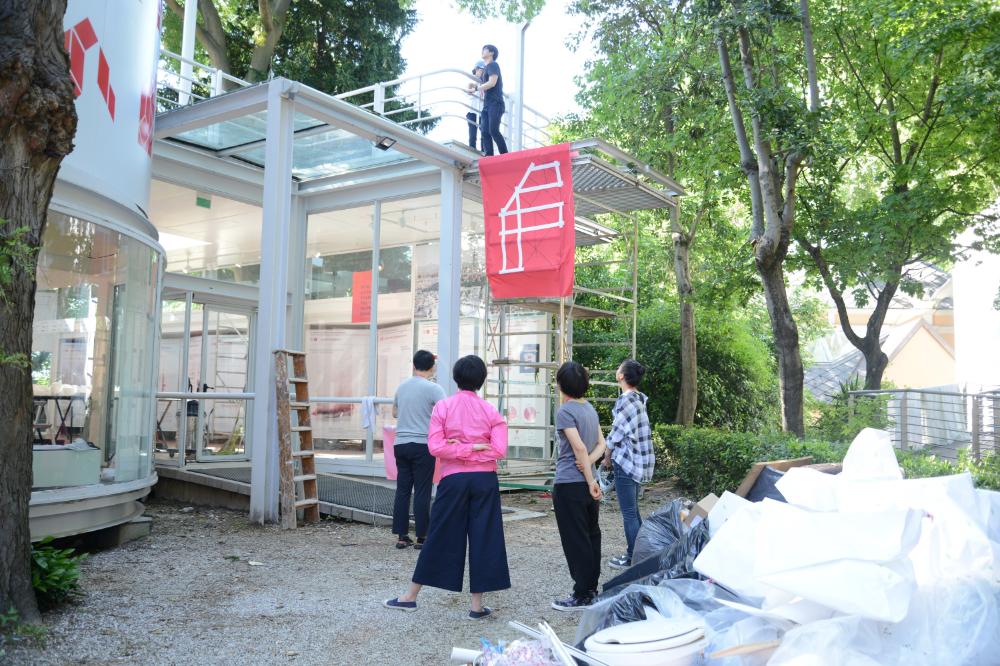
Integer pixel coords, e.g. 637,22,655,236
552,361,606,611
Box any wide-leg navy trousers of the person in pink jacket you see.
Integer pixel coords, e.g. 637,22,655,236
413,472,510,592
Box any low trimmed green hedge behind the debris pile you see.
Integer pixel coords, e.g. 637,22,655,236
653,425,846,497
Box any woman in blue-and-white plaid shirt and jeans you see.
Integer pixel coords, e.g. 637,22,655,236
604,359,656,569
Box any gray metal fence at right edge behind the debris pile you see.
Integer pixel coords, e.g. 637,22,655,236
848,389,1000,461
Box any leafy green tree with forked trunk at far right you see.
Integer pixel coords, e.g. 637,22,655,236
795,0,1000,389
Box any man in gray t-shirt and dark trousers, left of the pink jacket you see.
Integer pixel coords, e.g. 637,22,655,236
383,349,445,549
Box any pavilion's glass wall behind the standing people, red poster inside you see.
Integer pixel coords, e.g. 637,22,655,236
304,194,552,458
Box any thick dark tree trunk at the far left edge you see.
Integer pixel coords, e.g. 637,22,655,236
0,0,76,622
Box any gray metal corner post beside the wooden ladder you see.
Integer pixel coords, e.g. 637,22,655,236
250,79,295,523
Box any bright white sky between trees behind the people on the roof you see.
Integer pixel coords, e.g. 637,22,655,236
403,0,592,117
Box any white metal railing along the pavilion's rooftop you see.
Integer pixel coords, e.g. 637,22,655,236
156,49,552,149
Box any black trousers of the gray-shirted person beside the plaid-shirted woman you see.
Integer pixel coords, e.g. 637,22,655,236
552,481,601,597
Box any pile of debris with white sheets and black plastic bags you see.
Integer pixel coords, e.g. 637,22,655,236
576,429,1000,666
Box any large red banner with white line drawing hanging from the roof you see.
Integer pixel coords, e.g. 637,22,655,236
479,143,576,298
